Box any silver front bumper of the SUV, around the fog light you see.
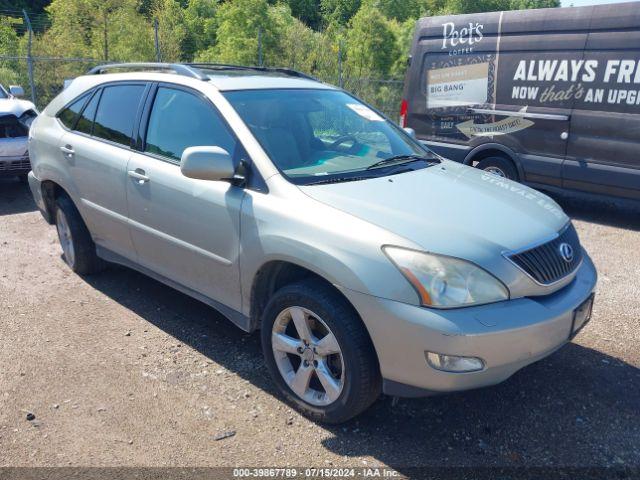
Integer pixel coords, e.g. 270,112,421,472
342,253,597,396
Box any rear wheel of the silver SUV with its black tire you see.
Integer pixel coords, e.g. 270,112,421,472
55,195,105,275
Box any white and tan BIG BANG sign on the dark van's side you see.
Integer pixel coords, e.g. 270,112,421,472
427,62,489,108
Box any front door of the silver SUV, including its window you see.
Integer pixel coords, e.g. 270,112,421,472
126,84,244,310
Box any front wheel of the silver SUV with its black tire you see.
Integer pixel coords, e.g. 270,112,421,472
261,280,382,424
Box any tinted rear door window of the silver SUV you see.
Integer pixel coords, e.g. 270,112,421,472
93,85,144,145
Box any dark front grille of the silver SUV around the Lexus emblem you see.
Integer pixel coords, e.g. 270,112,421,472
509,223,582,285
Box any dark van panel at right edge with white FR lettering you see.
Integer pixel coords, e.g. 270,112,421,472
563,4,640,199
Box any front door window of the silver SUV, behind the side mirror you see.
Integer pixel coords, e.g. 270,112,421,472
145,87,236,161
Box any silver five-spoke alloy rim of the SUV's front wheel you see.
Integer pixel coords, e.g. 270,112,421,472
271,307,345,406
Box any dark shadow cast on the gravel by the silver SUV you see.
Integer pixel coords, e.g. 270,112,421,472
80,267,640,470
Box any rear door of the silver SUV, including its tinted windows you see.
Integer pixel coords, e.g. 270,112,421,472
59,82,148,258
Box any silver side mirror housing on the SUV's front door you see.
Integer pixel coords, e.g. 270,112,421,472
180,147,236,180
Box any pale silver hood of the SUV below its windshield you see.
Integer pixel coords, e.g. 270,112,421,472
301,161,568,266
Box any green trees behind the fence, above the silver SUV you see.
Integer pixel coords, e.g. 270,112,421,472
0,0,559,108
